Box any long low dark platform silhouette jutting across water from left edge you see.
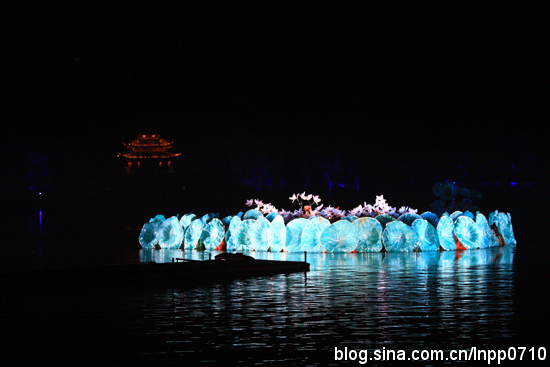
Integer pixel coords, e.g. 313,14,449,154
0,259,310,291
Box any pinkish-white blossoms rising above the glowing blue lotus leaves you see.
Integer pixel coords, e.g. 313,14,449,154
246,191,418,219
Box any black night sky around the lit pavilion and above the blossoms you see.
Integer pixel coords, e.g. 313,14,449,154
1,2,550,217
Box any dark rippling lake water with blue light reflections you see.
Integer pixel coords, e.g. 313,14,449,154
0,207,550,366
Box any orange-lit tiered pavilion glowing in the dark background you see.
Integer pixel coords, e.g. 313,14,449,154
118,135,181,171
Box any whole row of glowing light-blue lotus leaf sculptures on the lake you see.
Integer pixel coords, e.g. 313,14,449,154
139,204,516,252
